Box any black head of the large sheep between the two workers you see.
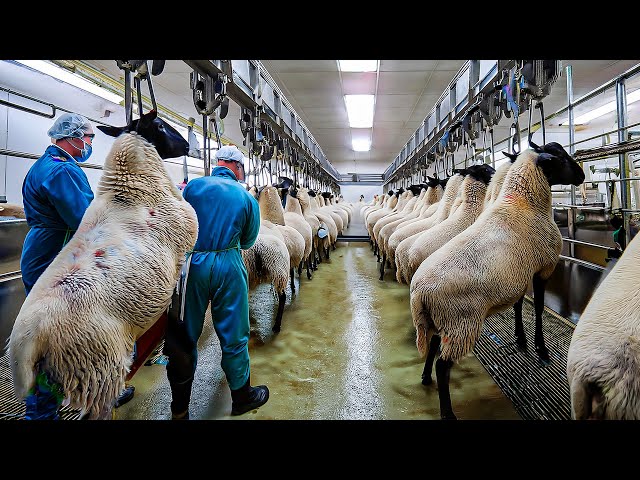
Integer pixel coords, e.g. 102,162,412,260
98,110,189,159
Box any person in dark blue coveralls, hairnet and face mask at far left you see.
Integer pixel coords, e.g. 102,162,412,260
20,113,135,420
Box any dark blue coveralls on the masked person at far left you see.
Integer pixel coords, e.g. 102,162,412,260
20,145,93,295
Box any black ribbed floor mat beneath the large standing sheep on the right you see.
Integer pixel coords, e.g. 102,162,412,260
474,298,574,420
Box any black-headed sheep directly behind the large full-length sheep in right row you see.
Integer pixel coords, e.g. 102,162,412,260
405,165,495,279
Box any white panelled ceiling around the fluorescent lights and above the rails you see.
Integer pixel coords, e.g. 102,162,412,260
84,60,640,174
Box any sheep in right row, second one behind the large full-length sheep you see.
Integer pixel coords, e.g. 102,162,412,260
395,173,464,285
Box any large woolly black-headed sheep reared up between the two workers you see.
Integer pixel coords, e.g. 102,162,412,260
8,110,198,419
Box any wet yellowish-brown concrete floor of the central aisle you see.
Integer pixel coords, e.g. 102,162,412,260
114,205,520,420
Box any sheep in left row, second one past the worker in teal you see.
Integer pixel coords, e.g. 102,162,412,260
258,186,311,293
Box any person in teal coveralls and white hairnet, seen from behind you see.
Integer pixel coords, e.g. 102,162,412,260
164,145,269,420
